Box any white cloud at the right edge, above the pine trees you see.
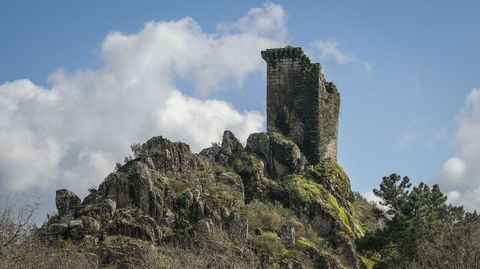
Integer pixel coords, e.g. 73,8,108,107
439,89,480,210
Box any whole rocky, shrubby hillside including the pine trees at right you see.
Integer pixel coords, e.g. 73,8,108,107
0,134,480,269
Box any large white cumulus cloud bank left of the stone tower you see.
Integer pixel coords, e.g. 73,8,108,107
0,3,286,217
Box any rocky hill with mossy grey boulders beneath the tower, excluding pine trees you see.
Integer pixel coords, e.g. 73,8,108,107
39,131,371,268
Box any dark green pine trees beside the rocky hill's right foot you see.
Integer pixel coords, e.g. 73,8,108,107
357,174,480,268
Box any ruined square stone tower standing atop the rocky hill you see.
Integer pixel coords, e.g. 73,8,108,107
262,46,340,164
